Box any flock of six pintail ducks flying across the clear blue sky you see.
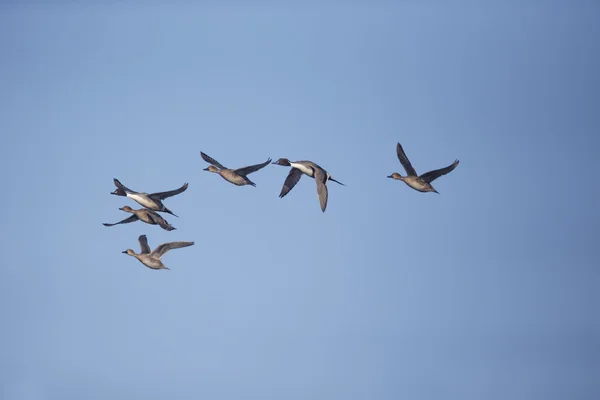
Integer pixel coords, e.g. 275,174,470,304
103,143,459,269
